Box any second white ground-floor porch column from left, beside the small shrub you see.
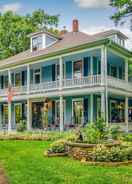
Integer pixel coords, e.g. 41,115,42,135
27,99,32,131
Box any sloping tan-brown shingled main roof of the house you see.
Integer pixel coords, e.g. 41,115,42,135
0,30,130,67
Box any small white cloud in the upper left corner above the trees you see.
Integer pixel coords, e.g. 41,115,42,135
0,2,22,12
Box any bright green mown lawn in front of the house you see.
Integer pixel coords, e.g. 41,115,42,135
0,141,132,184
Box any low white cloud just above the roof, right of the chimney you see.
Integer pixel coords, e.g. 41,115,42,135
82,26,132,51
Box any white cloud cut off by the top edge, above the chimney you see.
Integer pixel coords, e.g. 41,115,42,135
74,0,110,8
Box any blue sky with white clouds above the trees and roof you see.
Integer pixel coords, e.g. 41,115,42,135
0,0,132,49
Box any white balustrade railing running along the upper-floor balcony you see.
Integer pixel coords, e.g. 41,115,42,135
0,75,132,96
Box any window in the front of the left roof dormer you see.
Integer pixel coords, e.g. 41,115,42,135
32,36,43,51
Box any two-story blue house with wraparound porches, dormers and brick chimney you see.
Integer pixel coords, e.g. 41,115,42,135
0,20,132,131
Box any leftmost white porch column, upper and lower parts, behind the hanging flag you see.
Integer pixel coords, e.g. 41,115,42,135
8,70,12,131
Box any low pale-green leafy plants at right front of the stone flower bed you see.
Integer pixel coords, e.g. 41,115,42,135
91,145,127,162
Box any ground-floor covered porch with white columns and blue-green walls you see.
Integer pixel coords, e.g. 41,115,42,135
0,92,132,131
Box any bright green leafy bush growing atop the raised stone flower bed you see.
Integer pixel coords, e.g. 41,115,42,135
82,123,101,144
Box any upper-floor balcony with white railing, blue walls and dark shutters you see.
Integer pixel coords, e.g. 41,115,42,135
0,49,132,97
